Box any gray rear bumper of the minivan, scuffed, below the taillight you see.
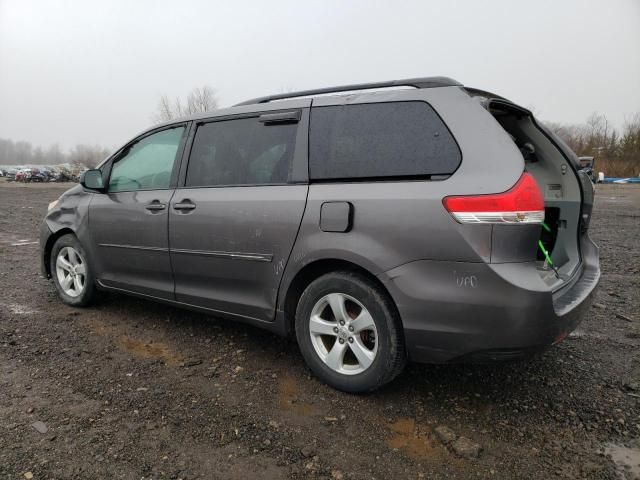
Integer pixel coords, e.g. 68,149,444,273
380,237,600,363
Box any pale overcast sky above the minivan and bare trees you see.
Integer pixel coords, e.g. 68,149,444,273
0,0,640,148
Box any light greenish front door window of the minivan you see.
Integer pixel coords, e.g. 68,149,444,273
109,127,184,192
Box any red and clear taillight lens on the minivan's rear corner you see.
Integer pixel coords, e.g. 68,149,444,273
442,172,544,223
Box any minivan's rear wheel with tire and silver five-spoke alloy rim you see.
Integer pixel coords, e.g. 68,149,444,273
296,271,406,393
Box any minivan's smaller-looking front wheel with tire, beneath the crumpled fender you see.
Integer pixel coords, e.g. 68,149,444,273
51,234,97,307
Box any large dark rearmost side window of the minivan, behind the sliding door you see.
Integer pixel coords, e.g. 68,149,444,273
309,102,461,180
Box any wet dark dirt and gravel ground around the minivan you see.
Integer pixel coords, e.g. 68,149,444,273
0,181,640,480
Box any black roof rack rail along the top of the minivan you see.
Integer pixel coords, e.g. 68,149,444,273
234,77,462,107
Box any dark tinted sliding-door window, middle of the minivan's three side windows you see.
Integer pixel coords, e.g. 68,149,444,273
186,118,297,187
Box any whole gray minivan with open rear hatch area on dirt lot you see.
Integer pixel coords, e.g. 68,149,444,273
41,77,600,392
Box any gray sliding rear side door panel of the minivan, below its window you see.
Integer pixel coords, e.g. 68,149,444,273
169,185,307,320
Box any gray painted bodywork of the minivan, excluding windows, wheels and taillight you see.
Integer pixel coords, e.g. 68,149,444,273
41,80,599,361
